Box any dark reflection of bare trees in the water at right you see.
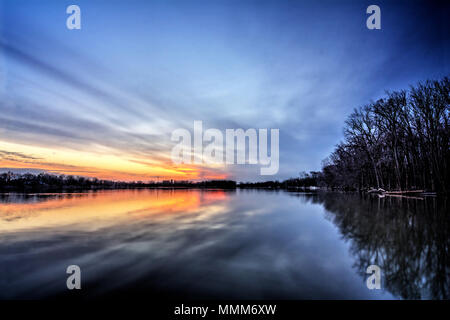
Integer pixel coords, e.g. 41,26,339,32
312,194,450,299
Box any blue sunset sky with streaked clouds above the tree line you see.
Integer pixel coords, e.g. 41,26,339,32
0,0,450,181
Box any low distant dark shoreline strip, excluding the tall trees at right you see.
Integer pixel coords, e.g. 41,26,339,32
0,171,442,197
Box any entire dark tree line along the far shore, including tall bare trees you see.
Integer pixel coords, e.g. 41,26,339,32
0,77,450,197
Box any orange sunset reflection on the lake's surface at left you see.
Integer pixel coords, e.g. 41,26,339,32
0,189,229,232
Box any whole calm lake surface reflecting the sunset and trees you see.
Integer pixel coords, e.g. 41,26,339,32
0,190,450,299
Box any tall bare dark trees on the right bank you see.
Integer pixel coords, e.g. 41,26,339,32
322,77,450,192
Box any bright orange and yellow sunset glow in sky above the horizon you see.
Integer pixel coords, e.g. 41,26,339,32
0,141,228,181
